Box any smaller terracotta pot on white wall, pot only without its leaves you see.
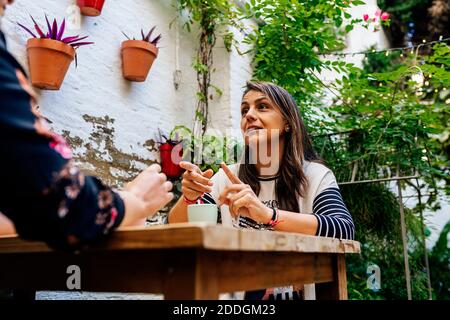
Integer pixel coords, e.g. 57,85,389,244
122,40,158,82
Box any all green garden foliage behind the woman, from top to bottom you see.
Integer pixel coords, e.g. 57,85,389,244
180,0,450,299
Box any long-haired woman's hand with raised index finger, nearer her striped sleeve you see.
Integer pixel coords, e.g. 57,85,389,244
219,163,272,223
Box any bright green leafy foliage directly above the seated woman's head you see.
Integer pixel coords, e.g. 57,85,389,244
241,0,363,109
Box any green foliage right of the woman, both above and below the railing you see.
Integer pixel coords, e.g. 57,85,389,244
324,44,450,299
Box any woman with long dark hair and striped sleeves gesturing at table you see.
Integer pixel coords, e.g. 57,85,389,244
169,82,355,298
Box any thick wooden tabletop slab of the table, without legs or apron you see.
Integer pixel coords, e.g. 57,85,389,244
0,223,361,255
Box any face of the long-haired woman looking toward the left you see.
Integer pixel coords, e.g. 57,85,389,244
241,90,286,145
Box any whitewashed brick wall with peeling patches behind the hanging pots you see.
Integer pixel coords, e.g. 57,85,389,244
2,0,250,185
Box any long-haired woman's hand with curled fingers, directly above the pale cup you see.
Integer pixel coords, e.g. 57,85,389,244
180,161,214,201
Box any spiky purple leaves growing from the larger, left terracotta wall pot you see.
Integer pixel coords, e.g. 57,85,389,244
17,15,93,49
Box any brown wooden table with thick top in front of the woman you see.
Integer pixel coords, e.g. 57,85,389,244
0,224,360,299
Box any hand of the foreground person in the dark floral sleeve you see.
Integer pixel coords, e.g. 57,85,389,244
119,164,173,226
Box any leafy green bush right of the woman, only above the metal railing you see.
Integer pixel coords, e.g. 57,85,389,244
328,44,450,200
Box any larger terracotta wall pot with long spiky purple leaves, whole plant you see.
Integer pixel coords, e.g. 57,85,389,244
18,16,93,90
